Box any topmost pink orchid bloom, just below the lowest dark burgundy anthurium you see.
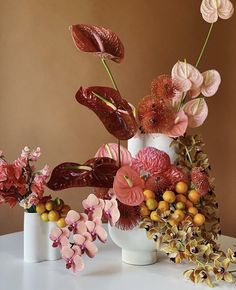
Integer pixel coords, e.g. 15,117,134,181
82,194,104,219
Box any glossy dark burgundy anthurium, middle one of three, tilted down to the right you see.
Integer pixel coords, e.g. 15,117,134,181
75,87,138,140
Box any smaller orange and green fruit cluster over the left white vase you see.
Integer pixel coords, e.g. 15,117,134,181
36,198,71,228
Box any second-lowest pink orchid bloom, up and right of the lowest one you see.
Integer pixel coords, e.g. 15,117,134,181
73,232,98,258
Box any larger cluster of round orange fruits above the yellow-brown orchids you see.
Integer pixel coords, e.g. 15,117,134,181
140,181,205,226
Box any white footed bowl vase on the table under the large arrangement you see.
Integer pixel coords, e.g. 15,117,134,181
108,225,157,266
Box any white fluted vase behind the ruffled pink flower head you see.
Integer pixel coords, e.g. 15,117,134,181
128,132,177,163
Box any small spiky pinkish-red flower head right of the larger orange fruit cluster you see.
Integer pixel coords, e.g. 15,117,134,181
191,167,210,195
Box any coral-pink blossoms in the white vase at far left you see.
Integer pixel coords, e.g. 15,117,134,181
0,147,51,212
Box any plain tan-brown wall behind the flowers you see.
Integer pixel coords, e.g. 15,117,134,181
0,0,236,237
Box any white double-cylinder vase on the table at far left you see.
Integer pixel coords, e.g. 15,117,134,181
24,212,61,263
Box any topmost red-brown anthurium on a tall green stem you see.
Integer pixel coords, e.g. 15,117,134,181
70,24,124,63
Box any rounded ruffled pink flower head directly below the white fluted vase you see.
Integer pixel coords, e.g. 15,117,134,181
132,147,171,174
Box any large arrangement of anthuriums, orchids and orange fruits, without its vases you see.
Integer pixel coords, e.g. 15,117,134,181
45,0,236,287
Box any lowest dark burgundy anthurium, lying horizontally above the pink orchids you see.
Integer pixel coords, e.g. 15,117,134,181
47,157,118,190
